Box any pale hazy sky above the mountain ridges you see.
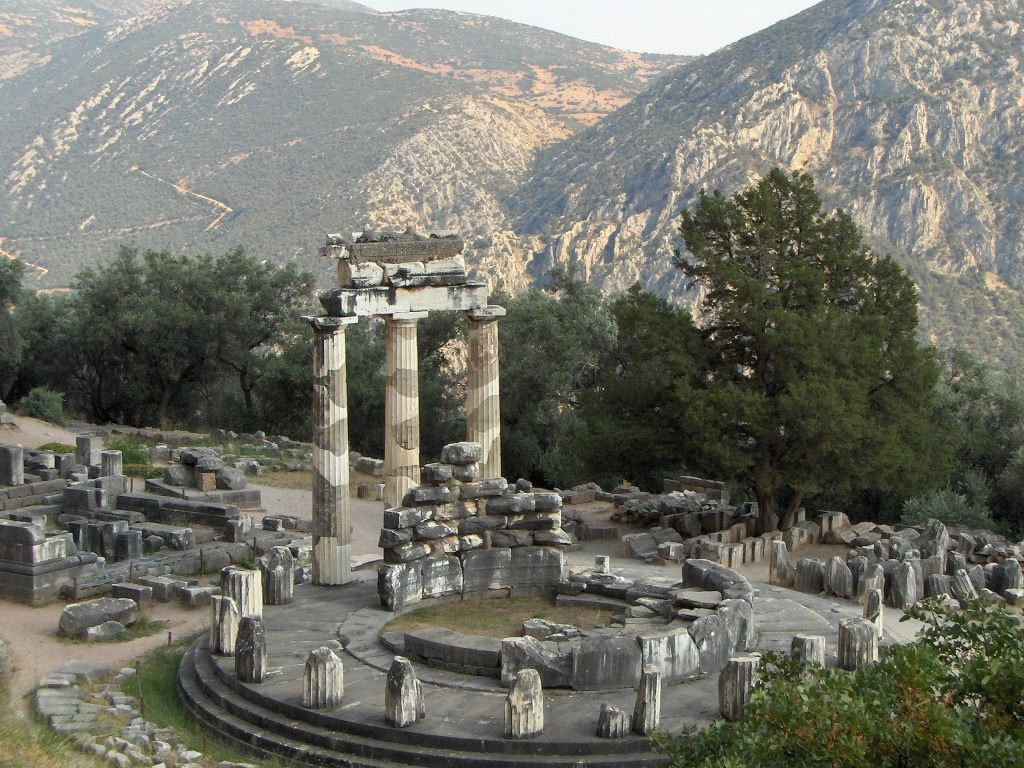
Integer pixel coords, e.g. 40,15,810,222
362,0,817,54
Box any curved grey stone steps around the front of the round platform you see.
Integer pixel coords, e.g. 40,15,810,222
178,638,662,768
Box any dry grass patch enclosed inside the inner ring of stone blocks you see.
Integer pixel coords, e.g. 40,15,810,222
382,597,612,637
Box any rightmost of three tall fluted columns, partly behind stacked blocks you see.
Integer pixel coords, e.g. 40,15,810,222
466,305,505,478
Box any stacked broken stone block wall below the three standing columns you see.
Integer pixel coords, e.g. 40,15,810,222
378,442,572,612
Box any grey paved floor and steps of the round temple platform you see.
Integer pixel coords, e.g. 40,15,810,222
178,571,880,768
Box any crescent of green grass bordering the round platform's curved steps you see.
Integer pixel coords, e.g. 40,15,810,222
130,632,289,768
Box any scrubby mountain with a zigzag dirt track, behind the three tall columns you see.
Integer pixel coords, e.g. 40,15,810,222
0,0,682,288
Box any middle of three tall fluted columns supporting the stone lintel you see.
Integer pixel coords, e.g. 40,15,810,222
384,312,427,507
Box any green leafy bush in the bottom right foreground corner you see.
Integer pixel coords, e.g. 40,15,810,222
653,598,1024,768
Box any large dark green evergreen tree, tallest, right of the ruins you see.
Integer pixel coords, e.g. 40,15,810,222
676,169,938,529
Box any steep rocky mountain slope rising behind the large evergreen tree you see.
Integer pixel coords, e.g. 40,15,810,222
510,0,1024,364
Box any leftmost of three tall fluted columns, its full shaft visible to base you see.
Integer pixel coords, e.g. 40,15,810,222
304,316,356,585
